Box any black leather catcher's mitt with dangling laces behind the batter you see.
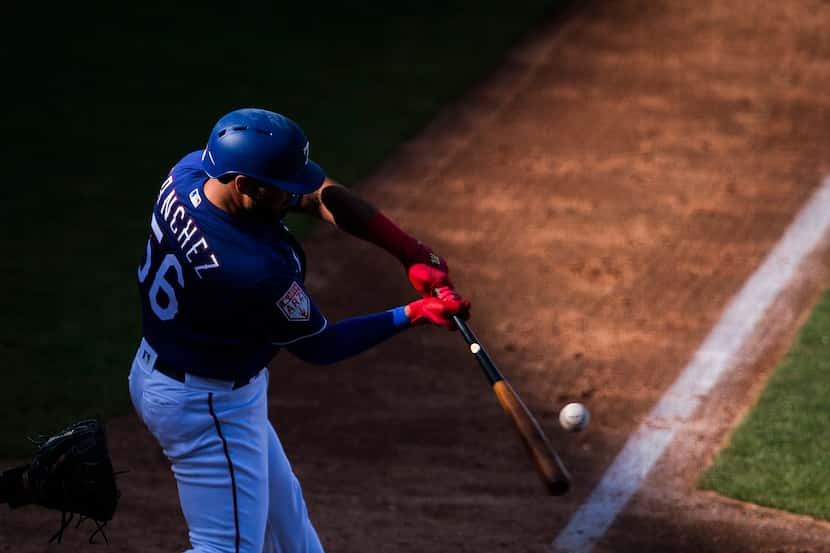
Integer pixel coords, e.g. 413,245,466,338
28,419,119,543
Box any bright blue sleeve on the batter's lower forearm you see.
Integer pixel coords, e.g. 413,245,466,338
287,307,409,365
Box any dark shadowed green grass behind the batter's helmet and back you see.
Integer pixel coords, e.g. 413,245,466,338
0,0,558,457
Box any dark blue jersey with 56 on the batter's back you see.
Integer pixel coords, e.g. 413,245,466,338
138,151,327,380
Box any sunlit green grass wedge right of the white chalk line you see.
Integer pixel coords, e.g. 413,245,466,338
700,291,830,520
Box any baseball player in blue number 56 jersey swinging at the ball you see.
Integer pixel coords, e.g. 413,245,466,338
129,109,470,553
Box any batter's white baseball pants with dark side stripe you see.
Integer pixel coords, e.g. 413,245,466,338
129,340,323,553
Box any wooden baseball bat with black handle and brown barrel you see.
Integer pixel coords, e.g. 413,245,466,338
453,316,571,495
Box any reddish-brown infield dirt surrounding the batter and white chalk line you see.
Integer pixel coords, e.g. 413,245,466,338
0,0,830,553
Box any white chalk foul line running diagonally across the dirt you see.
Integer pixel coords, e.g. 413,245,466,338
553,177,830,553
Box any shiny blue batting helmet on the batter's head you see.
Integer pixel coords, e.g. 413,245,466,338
202,108,326,194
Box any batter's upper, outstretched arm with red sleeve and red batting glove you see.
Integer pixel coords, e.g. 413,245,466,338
298,179,452,298
